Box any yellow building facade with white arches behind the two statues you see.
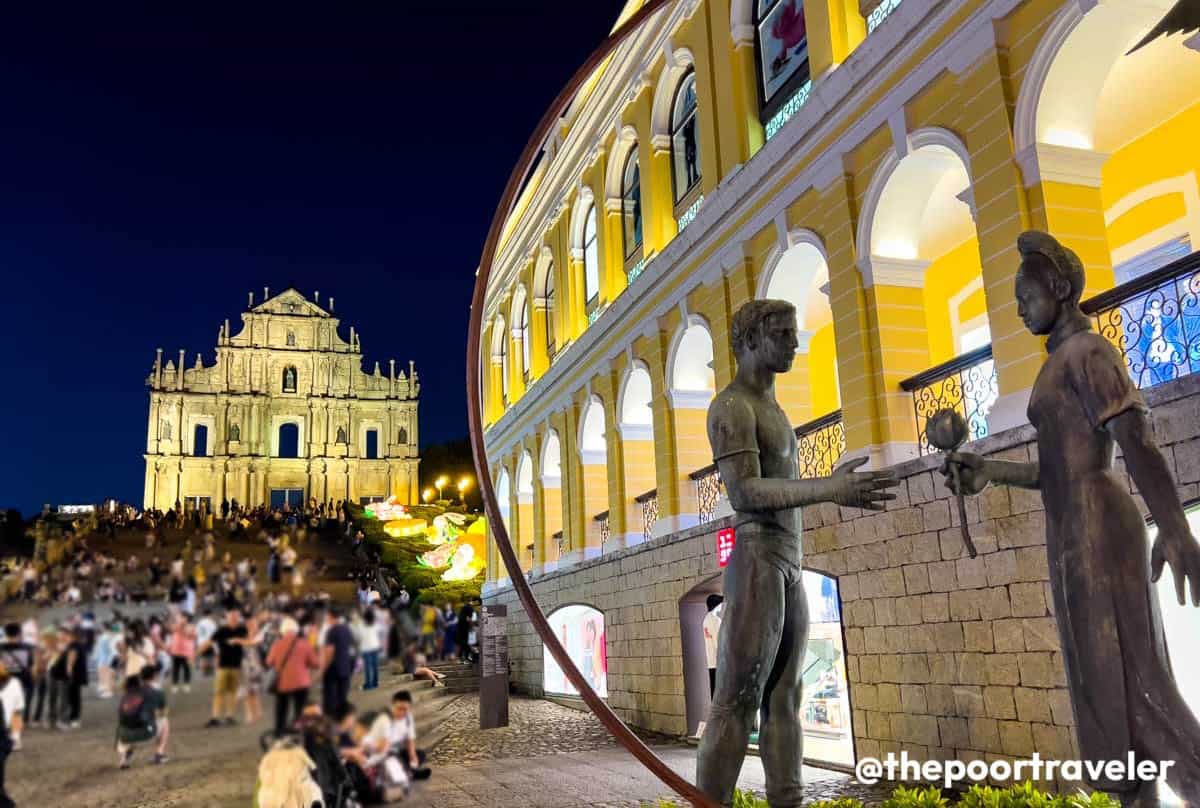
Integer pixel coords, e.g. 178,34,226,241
479,0,1200,583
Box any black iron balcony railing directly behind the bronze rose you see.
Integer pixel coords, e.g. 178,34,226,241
900,345,1000,455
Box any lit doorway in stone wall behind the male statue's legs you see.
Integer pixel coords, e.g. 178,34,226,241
679,569,856,768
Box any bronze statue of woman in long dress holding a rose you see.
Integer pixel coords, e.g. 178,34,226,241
942,232,1200,806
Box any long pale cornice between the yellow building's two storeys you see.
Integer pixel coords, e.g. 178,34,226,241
486,0,1021,465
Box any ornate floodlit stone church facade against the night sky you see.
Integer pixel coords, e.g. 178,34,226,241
144,289,421,513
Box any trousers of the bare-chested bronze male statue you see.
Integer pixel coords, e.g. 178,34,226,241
696,535,809,808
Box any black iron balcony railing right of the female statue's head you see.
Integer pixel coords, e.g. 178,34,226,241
1082,252,1200,388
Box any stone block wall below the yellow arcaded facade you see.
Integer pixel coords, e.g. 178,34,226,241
487,377,1200,773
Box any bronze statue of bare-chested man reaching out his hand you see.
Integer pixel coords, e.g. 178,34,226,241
697,300,896,808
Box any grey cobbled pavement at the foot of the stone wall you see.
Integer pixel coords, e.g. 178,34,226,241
409,696,886,808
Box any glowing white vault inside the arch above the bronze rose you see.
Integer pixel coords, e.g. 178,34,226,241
857,127,974,277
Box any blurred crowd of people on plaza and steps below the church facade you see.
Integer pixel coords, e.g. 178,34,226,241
0,501,478,808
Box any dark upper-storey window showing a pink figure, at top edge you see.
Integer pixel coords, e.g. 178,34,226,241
755,0,809,121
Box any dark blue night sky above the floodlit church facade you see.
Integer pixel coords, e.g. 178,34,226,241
0,0,622,513
